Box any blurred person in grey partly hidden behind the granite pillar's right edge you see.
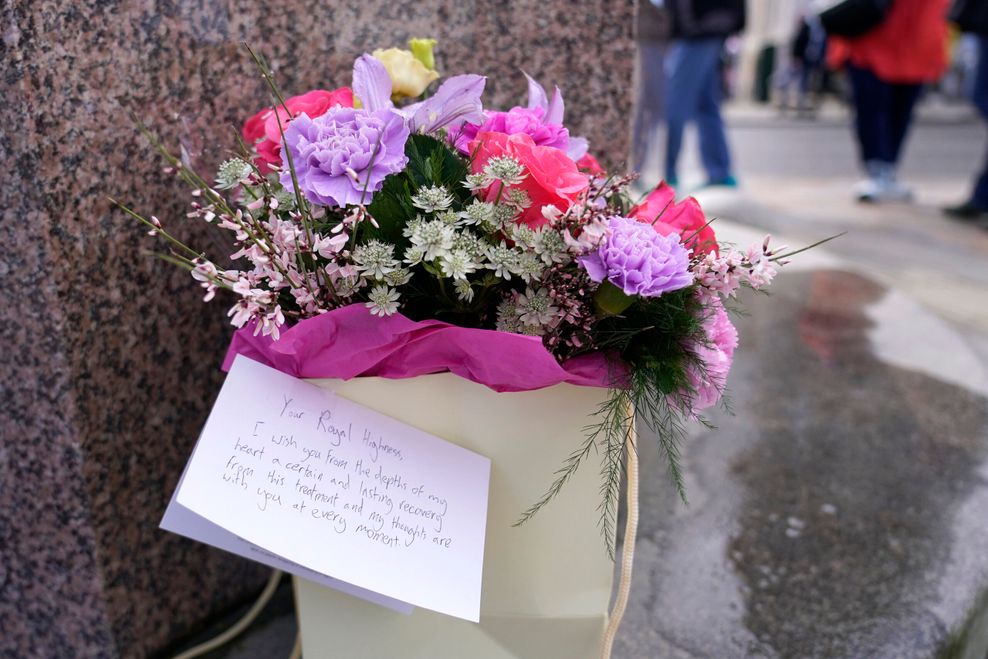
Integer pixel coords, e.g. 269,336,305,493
631,0,670,189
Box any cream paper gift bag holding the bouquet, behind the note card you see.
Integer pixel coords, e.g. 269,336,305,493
295,373,614,659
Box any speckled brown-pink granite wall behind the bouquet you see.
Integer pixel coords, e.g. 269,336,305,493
0,0,634,657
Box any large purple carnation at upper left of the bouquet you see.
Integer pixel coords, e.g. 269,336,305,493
281,107,408,206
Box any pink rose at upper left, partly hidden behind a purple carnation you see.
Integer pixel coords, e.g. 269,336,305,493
241,87,353,174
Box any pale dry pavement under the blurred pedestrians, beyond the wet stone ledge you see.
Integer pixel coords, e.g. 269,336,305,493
642,102,988,342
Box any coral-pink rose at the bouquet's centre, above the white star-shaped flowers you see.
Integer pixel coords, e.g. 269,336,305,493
470,132,590,229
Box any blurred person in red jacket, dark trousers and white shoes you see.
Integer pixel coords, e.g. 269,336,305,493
827,0,949,202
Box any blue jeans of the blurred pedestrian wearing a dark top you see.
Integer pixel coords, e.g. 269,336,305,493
665,37,731,182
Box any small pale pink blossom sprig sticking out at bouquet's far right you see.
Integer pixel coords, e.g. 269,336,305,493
692,235,787,302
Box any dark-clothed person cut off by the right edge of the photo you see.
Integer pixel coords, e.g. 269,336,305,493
943,0,988,220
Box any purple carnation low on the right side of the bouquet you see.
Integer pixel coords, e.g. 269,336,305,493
578,217,693,297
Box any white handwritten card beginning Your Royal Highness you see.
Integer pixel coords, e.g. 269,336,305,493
165,357,502,622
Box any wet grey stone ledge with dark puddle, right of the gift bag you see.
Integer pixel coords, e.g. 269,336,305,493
616,269,988,659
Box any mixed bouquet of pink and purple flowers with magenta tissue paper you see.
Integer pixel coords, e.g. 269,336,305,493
119,40,812,547
